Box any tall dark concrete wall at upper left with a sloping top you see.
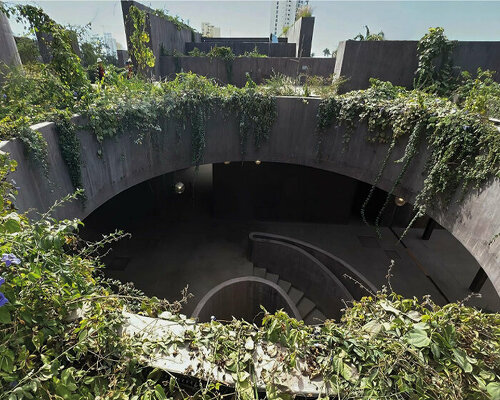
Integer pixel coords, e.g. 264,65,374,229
121,1,201,77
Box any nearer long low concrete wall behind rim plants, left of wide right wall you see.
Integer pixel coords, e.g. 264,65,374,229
160,56,335,87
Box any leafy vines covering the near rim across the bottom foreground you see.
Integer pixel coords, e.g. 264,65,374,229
0,155,500,400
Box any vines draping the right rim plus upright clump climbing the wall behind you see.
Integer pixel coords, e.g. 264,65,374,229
318,28,500,236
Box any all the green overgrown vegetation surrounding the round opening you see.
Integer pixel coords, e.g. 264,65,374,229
0,6,500,400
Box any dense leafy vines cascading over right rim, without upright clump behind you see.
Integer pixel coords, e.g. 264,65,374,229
318,80,500,234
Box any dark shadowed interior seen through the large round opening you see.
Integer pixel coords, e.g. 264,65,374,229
83,162,500,323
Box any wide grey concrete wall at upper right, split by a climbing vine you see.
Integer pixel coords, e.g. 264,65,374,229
335,40,500,92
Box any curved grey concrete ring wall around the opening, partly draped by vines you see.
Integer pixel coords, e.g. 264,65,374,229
0,97,500,293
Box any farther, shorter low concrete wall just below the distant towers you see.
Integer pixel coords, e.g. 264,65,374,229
184,40,296,57
